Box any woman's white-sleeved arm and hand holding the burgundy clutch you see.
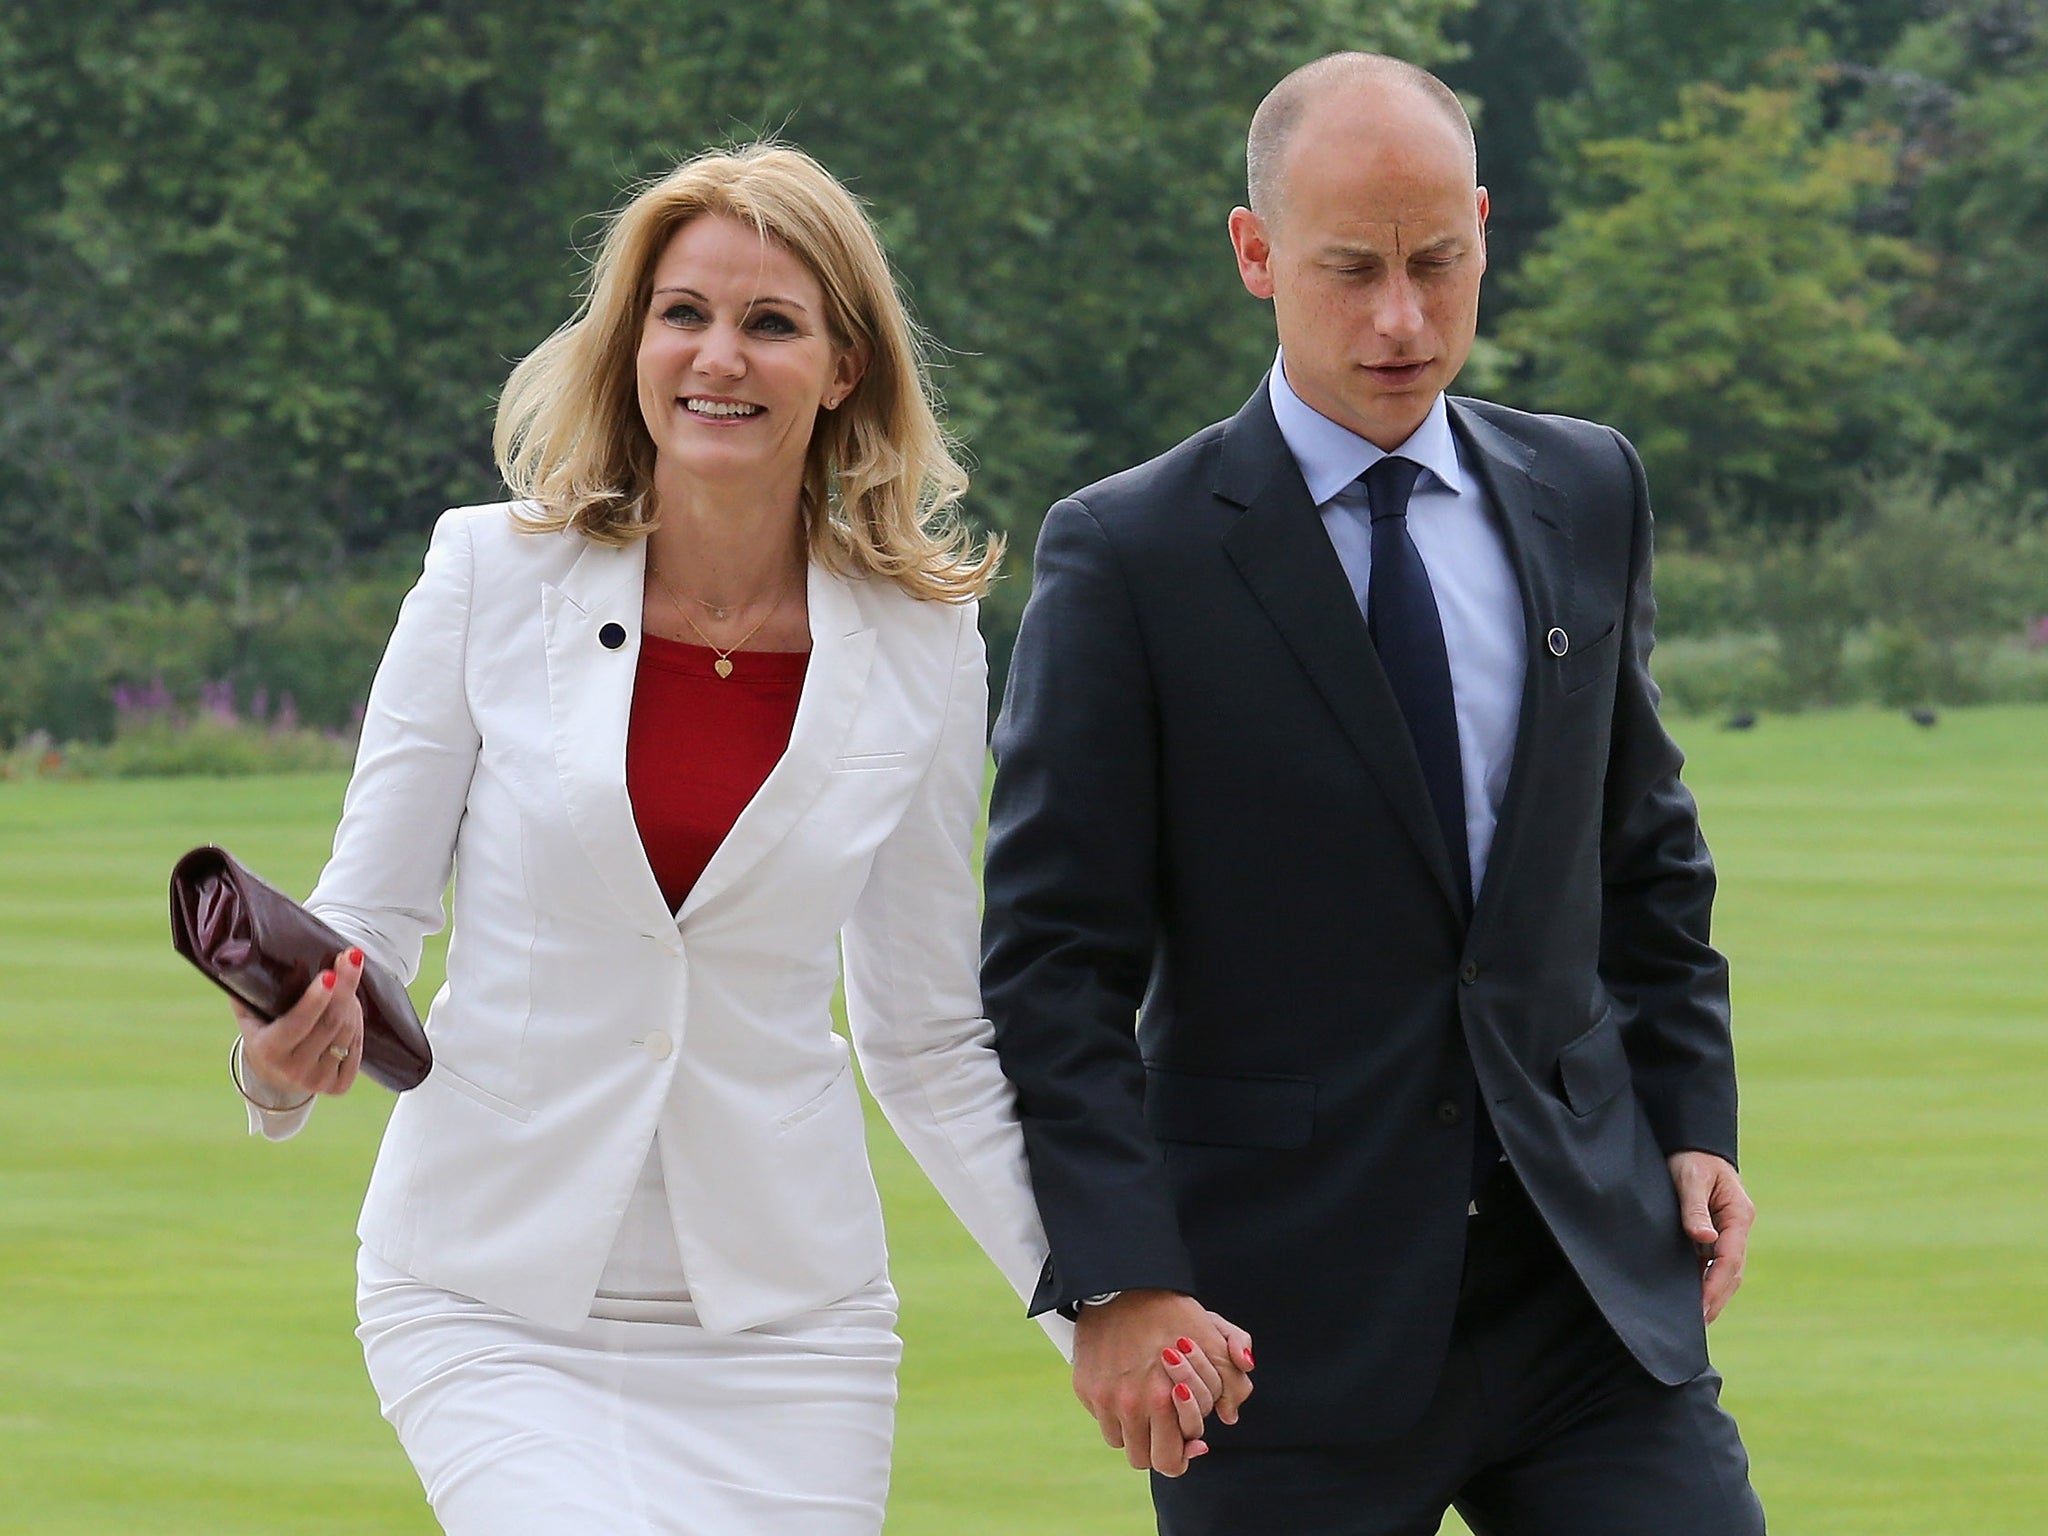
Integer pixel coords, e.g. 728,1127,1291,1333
242,510,481,1141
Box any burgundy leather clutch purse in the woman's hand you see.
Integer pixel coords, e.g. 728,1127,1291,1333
170,848,434,1094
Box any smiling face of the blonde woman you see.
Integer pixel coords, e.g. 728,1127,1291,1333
635,213,860,489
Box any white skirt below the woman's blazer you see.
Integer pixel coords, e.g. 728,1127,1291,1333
356,1163,903,1536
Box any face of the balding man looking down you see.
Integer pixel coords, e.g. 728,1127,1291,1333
1231,88,1487,449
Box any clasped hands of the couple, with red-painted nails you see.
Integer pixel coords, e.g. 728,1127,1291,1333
1073,1290,1251,1477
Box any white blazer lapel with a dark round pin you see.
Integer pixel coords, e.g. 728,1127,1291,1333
541,541,670,926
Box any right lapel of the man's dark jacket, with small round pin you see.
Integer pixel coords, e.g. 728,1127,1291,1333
1450,399,1573,928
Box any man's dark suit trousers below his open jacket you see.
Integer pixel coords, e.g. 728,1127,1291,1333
1153,1167,1763,1536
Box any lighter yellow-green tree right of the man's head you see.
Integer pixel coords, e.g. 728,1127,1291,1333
1501,84,1923,524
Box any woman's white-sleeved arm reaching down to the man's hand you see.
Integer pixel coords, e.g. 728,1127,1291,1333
842,604,1073,1354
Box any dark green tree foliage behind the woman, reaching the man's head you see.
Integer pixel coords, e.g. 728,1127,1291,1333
0,0,1466,621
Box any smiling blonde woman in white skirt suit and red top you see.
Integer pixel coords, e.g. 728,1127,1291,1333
236,145,1236,1536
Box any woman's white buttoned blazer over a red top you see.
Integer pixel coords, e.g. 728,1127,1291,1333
260,506,1065,1343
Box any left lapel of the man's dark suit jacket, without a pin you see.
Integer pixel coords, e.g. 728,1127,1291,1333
1217,387,1464,913
